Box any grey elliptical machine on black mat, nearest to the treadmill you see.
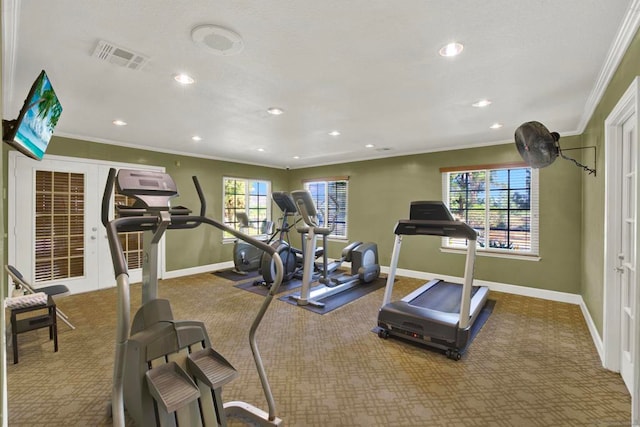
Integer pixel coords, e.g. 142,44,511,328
289,190,380,307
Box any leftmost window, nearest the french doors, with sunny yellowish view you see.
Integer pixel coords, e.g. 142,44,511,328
223,177,271,240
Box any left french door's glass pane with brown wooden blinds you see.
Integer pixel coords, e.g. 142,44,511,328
33,171,85,282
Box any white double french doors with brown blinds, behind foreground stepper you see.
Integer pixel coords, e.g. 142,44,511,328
8,152,164,293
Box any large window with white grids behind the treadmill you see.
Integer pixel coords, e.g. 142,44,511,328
442,166,538,255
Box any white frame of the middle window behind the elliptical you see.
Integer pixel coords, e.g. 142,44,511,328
302,177,349,240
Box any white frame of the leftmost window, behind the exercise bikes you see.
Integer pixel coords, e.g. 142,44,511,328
222,176,272,243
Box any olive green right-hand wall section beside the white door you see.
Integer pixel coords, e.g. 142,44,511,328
580,25,640,336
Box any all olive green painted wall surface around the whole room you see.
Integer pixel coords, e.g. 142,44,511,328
0,22,640,338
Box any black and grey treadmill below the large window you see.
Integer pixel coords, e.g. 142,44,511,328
376,201,489,360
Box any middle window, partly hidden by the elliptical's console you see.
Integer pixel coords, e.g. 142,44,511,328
304,178,349,239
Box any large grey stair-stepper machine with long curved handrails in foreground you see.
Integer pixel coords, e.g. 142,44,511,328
102,169,283,426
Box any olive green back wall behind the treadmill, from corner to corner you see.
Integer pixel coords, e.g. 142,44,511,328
289,137,582,293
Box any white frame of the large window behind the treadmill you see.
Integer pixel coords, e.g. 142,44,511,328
440,163,540,261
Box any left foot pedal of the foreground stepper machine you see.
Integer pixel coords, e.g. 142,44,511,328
145,362,200,413
